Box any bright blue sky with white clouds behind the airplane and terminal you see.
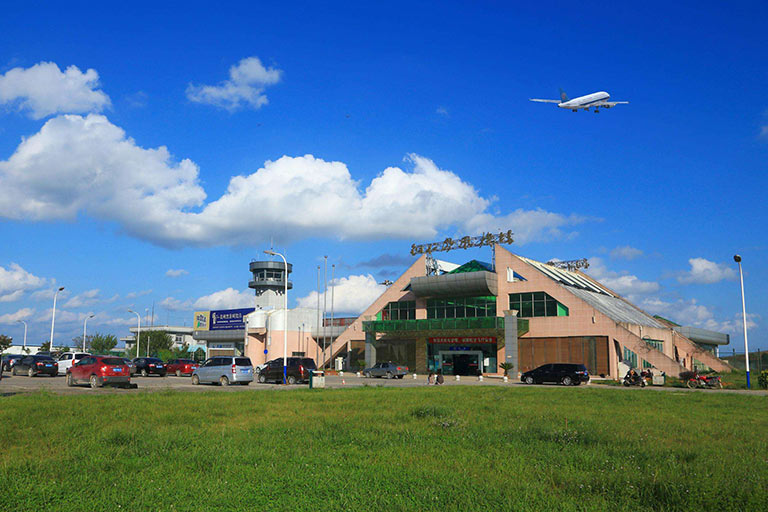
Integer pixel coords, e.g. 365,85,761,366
0,2,768,350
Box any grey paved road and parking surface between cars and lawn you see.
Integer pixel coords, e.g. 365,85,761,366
0,373,768,395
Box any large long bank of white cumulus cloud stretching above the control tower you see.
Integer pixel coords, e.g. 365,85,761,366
0,114,585,247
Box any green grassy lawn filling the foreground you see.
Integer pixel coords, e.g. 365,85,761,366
0,386,768,512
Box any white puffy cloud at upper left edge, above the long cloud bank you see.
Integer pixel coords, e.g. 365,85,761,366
0,62,110,119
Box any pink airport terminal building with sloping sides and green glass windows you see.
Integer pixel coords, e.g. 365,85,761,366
325,245,729,378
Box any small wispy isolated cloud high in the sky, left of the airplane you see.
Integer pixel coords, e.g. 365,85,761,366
187,57,282,112
